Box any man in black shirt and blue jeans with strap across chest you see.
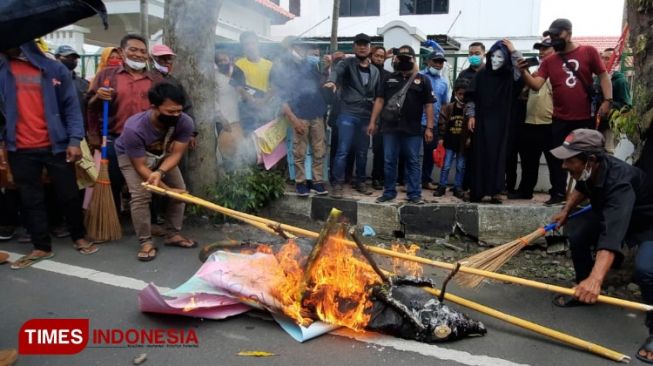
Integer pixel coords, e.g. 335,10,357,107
368,46,434,204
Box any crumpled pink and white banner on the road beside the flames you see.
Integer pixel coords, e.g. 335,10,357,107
138,251,339,342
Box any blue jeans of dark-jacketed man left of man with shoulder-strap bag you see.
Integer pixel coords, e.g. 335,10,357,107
333,113,370,184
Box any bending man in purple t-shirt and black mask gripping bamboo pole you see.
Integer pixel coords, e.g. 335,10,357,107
115,82,197,262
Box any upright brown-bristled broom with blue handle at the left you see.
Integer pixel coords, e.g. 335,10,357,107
84,79,122,241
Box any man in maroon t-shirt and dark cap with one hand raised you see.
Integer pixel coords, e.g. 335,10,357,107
519,19,612,205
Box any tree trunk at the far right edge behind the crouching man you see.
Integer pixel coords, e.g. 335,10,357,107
627,0,653,167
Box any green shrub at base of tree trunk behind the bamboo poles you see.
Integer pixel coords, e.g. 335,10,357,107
209,167,286,220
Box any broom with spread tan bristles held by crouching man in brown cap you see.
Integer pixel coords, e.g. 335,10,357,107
456,205,592,288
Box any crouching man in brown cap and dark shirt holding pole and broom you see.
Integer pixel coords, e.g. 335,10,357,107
551,129,653,363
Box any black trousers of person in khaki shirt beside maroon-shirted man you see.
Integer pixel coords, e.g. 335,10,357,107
518,124,558,196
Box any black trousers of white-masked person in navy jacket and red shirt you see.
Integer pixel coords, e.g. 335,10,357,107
9,149,86,252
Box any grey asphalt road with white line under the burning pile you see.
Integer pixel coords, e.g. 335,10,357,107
0,225,647,366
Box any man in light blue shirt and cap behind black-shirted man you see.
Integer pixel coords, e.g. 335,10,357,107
421,51,449,190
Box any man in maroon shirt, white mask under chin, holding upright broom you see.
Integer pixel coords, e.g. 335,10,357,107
88,34,164,212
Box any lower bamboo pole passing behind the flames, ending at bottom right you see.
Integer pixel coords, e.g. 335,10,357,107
182,189,630,363
